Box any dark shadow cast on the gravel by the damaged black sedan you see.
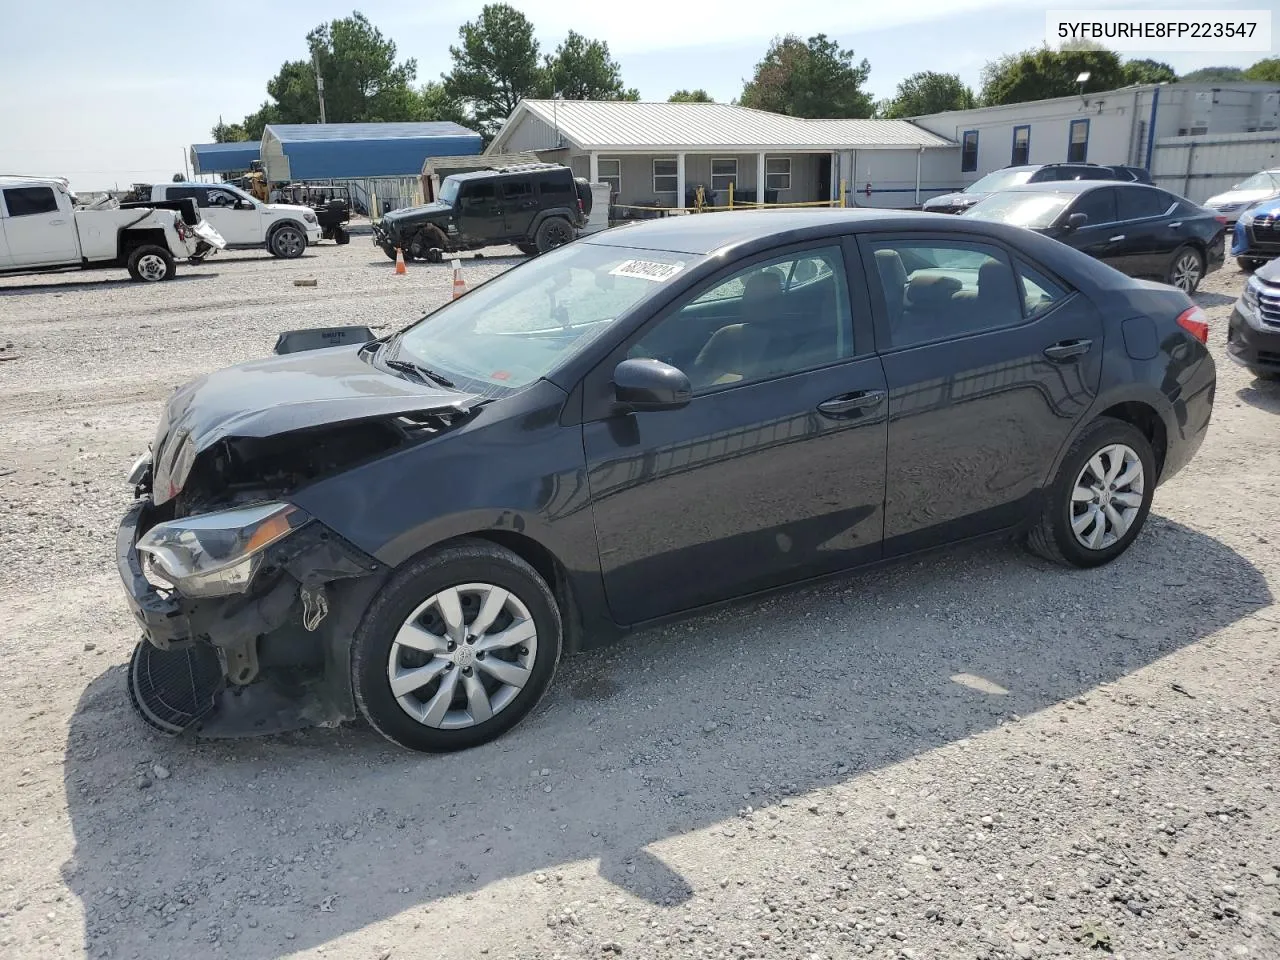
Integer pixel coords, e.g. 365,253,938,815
63,515,1271,960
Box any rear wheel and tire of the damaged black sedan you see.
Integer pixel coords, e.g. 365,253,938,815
1027,417,1157,568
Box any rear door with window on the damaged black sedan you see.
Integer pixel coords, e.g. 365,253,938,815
859,233,1102,557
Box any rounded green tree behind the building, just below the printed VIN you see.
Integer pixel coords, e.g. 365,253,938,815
982,46,1125,106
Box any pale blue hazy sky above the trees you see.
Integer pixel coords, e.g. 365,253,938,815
0,0,1280,191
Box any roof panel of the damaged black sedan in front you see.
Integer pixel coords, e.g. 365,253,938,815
580,207,1044,256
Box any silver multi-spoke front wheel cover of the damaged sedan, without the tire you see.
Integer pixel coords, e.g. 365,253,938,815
387,584,538,730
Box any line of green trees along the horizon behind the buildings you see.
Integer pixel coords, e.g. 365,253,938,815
212,4,1280,143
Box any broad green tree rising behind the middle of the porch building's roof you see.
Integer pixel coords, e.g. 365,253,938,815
740,33,876,118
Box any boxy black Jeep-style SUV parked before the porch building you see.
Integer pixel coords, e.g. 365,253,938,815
374,164,591,260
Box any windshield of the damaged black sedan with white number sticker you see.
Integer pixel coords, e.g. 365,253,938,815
396,243,703,396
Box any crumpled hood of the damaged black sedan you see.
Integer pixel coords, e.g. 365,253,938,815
152,347,476,504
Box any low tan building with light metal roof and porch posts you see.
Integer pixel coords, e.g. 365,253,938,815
485,100,959,207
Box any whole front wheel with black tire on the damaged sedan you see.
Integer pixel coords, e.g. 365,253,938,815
351,540,563,753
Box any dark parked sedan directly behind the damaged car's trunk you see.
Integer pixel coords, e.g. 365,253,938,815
964,180,1226,293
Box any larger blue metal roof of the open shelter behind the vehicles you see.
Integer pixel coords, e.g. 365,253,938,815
262,120,483,180
